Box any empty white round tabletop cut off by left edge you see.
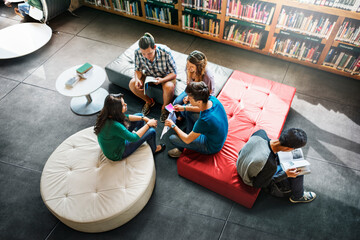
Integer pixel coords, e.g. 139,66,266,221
0,23,52,59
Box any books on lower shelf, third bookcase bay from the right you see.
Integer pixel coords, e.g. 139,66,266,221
224,24,266,49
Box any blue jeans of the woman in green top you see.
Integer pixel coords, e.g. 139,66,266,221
122,113,156,159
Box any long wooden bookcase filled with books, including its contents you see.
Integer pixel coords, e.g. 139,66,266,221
84,0,360,80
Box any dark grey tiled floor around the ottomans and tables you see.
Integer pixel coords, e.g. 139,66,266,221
0,5,360,240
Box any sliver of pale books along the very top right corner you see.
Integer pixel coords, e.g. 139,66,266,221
297,0,360,12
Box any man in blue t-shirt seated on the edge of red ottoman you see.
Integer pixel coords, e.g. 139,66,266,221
165,82,228,158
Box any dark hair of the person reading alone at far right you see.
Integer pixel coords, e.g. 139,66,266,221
279,128,307,148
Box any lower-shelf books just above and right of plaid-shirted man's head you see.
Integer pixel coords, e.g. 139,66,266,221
145,4,177,24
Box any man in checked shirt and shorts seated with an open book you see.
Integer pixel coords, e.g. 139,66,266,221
129,33,176,122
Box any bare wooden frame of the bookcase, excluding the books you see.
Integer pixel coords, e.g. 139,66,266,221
84,0,360,80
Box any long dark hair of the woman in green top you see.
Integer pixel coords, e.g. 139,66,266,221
94,93,127,135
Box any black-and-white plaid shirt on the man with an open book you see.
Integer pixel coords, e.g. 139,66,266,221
135,46,176,77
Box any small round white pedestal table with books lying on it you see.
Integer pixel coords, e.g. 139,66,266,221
56,65,109,115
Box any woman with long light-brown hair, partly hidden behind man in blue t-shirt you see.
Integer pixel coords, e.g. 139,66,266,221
173,50,215,125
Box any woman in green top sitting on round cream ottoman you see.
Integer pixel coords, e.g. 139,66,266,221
94,93,165,161
